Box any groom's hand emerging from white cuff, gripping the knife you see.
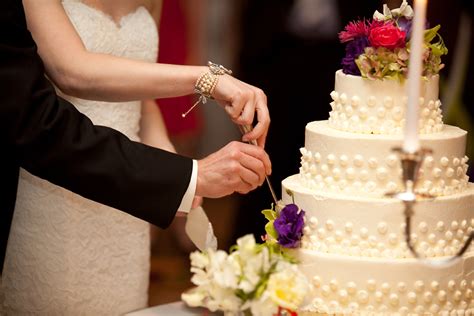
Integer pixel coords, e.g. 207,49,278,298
196,141,271,198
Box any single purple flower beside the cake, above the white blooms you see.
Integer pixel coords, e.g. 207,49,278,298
273,204,304,248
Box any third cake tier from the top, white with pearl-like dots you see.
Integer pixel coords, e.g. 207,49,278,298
282,175,474,258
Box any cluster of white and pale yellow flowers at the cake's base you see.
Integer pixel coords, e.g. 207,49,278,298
181,235,309,316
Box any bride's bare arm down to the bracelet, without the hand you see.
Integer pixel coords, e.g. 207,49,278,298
23,0,202,101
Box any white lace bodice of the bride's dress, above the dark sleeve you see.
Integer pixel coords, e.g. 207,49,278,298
59,0,158,140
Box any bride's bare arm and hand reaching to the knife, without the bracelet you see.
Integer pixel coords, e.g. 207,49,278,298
23,0,270,146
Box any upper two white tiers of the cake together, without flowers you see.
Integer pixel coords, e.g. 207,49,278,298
300,70,469,197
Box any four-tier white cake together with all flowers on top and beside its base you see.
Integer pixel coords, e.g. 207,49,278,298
183,1,474,315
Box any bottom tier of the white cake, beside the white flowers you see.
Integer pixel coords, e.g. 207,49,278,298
295,250,474,315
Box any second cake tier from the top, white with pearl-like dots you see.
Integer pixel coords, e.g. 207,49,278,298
300,121,469,197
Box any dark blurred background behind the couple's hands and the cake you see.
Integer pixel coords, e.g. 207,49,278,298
149,0,474,306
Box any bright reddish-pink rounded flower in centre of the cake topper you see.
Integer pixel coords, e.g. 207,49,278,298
369,23,406,50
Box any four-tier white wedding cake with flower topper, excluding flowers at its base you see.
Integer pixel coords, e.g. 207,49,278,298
282,2,474,315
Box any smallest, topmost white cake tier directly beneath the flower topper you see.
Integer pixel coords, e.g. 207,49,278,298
329,70,443,135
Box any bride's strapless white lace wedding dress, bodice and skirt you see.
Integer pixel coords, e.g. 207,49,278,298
0,0,158,315
